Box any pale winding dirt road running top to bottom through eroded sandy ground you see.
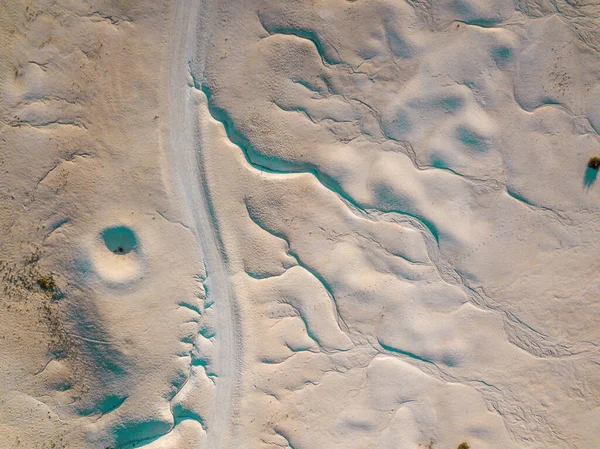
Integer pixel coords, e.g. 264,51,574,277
166,0,241,449
